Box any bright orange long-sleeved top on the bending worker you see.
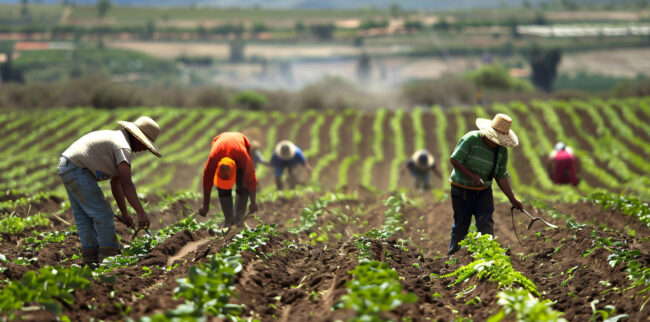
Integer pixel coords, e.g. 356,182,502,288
203,132,257,192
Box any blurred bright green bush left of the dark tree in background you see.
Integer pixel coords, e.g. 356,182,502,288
465,65,534,92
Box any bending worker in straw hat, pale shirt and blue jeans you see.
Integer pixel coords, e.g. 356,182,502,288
57,116,160,266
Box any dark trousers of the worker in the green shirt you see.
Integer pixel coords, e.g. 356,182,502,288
449,185,494,254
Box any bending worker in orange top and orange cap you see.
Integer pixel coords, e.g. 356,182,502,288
199,132,257,227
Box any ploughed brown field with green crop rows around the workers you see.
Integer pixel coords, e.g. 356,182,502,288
0,98,650,321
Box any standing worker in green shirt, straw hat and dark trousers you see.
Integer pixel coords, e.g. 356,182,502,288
449,114,522,255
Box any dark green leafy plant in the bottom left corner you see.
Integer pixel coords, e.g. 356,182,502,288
0,266,92,319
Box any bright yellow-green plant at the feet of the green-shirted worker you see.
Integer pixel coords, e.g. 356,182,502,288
441,233,539,296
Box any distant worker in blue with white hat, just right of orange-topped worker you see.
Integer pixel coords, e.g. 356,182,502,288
271,140,312,190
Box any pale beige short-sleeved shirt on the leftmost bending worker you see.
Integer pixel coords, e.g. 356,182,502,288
62,130,132,180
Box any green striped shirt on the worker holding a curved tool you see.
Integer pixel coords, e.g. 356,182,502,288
449,131,510,187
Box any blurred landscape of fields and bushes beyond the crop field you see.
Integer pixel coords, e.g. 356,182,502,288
0,0,650,111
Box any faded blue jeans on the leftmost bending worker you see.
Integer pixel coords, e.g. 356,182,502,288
57,157,120,249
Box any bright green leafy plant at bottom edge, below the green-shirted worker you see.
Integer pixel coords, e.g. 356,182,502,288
487,288,566,322
